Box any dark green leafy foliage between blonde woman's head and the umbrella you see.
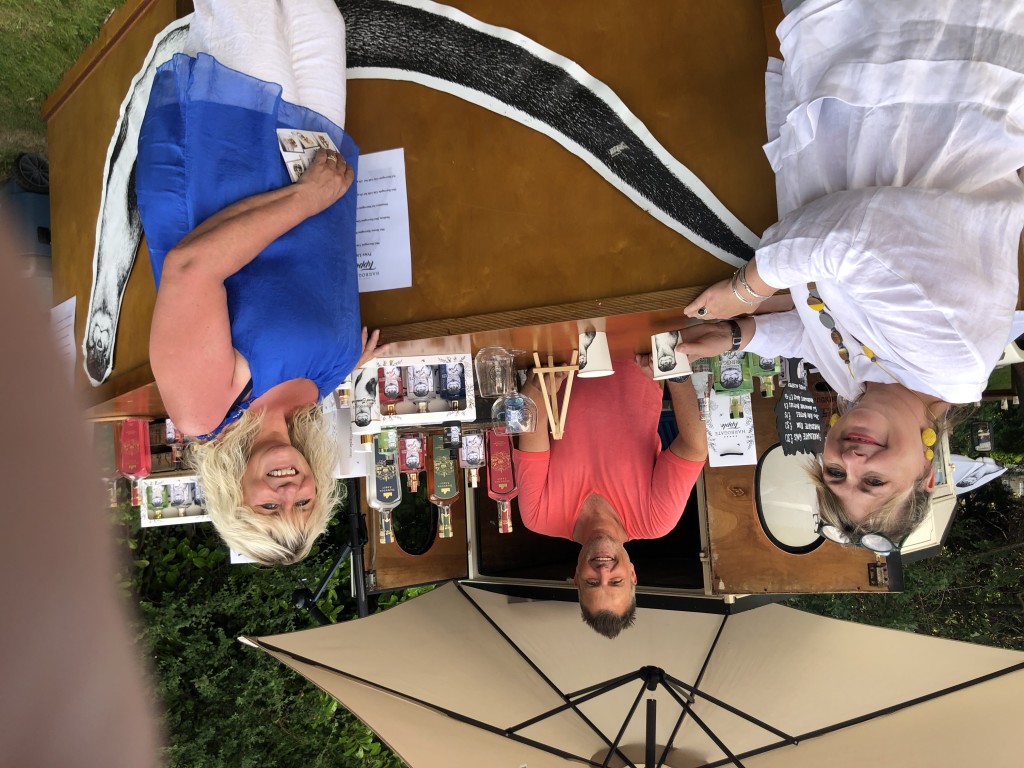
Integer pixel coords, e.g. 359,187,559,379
120,493,422,768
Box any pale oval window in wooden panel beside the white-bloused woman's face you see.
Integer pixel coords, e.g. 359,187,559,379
754,444,824,555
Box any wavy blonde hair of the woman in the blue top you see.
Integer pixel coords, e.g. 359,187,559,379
189,403,338,565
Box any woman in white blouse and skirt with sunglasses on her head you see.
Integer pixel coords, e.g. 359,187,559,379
679,0,1024,550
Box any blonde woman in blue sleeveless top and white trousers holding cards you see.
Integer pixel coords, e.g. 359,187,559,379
136,0,377,564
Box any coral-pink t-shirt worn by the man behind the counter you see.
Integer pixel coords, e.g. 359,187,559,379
515,360,703,539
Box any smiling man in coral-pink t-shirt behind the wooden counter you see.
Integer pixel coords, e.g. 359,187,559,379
515,359,708,637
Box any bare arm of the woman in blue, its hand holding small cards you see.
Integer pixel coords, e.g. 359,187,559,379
150,153,353,434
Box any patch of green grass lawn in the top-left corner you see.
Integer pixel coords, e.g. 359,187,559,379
0,0,124,179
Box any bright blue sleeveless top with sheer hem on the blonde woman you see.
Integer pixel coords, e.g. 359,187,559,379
135,53,362,437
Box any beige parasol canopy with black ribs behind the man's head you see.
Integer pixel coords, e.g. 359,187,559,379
245,584,1024,768
